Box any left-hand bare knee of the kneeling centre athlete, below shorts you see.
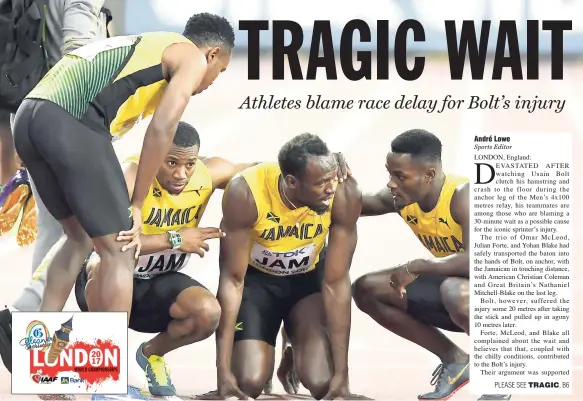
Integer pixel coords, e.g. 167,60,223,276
231,340,275,398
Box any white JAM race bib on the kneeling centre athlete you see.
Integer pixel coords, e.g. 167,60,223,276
250,243,316,276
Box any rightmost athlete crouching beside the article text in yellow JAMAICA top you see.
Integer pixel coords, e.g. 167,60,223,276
353,129,509,400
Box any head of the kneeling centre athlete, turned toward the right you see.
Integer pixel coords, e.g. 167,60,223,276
278,134,338,214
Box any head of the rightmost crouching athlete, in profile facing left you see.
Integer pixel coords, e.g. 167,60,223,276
386,129,441,208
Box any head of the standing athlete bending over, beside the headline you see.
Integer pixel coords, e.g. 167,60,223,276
183,13,235,93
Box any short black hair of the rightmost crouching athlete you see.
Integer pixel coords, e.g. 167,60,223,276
391,129,441,162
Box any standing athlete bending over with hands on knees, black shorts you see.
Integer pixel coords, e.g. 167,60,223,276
14,13,235,319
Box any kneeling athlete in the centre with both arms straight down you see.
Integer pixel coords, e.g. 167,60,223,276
210,134,362,399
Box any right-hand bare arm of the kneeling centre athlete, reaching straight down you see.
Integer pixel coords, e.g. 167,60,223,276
322,177,362,377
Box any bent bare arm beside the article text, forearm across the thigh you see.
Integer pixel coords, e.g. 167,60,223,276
409,184,470,278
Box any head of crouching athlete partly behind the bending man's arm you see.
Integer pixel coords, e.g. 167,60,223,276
156,121,200,195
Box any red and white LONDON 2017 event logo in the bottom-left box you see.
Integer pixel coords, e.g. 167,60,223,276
13,313,127,394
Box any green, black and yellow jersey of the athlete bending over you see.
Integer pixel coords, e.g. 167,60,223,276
27,32,192,137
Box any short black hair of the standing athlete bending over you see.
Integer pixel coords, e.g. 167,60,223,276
183,13,235,53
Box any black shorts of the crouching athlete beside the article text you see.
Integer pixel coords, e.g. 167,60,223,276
407,275,464,333
